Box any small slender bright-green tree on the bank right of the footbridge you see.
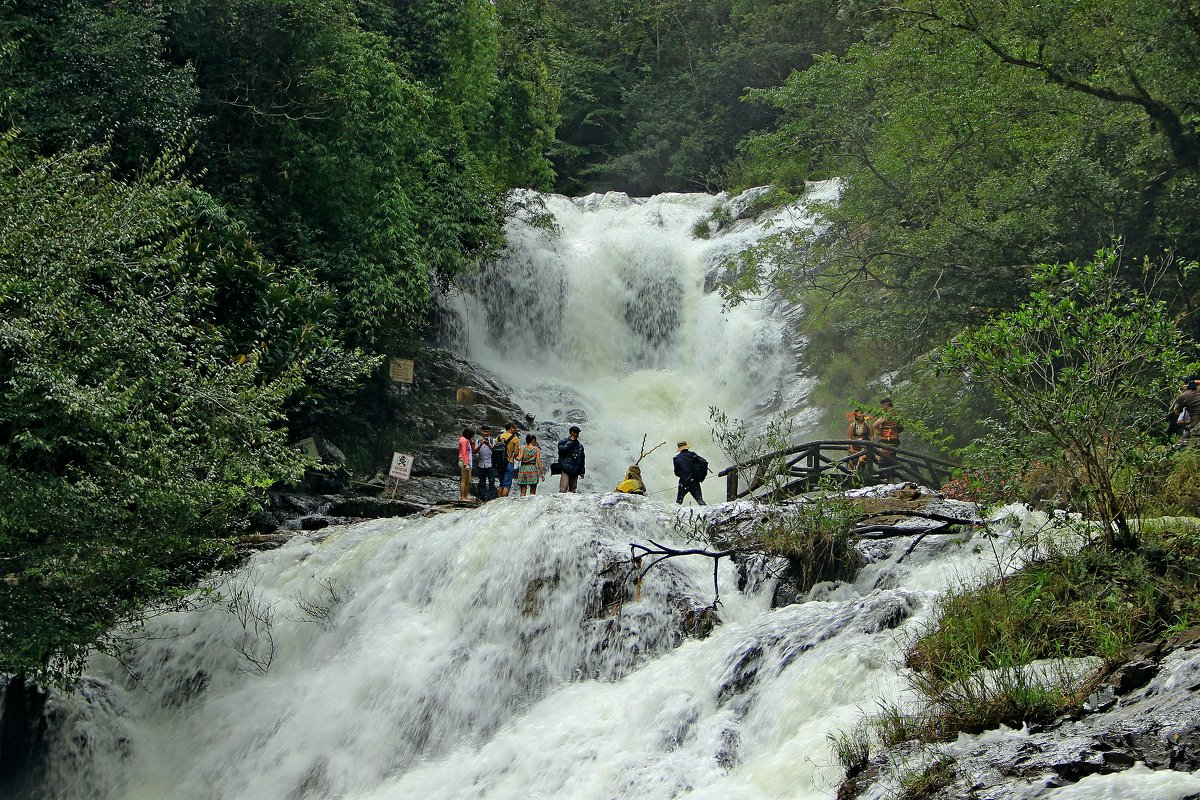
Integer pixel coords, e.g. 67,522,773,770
946,252,1187,547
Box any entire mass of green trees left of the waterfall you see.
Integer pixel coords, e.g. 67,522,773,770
0,0,557,682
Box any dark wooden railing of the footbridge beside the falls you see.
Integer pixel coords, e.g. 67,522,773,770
718,439,955,500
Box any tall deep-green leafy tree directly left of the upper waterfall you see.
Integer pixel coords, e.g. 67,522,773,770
170,0,500,349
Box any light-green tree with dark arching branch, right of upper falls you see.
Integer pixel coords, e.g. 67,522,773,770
734,0,1200,397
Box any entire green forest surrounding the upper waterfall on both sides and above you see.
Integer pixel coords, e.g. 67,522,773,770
0,0,1200,681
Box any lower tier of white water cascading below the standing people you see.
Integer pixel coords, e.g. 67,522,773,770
41,495,1008,800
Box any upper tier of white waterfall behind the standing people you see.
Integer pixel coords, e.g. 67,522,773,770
452,187,838,492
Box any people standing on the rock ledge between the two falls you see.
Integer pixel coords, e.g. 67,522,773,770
458,422,708,505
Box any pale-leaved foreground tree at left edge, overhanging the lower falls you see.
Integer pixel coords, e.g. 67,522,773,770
0,137,372,682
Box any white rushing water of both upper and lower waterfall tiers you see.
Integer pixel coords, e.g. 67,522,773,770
23,185,1200,800
